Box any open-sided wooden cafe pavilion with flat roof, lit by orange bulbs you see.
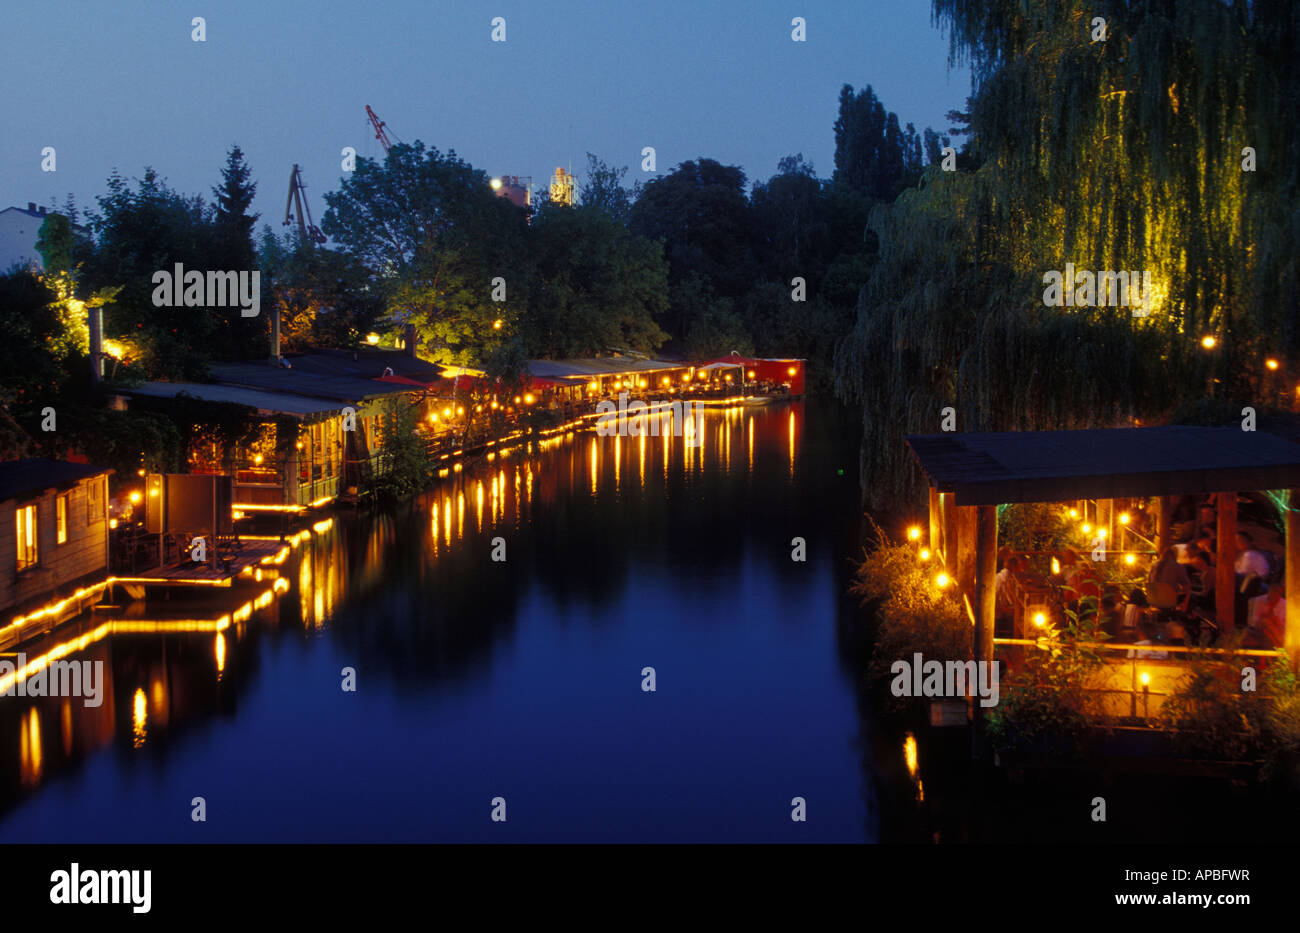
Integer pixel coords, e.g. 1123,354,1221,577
906,425,1300,722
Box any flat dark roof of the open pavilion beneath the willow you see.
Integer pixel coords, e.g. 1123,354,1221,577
907,425,1300,505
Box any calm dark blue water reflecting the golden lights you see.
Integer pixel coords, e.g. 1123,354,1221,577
0,403,910,842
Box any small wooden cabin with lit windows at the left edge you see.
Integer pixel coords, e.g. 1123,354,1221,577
0,460,112,621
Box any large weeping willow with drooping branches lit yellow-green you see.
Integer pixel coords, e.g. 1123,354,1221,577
836,0,1300,504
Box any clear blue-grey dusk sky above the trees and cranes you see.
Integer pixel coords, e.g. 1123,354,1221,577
0,0,970,231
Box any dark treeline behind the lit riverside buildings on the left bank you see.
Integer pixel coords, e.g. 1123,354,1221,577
0,86,948,473
